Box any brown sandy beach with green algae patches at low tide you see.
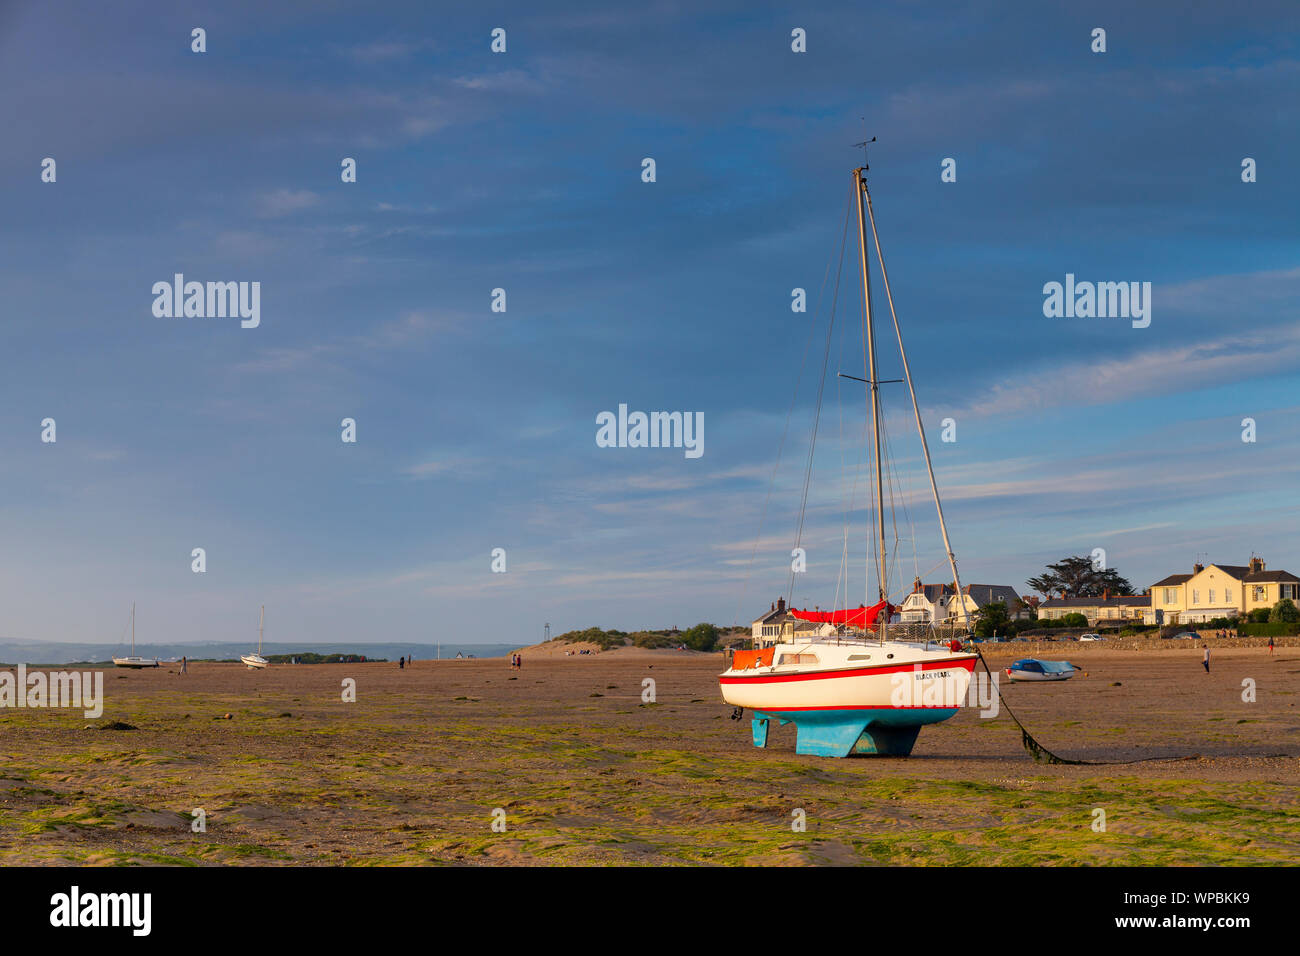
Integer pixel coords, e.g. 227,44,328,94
0,644,1300,865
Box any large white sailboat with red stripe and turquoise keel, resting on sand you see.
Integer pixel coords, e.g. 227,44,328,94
718,149,976,757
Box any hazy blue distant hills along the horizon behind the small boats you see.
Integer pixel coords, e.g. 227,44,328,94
0,640,515,666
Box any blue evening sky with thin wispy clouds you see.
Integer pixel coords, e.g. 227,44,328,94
0,0,1300,643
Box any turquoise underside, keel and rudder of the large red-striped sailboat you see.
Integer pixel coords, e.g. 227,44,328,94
753,708,957,757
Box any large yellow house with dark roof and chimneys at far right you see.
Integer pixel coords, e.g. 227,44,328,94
1149,558,1300,624
